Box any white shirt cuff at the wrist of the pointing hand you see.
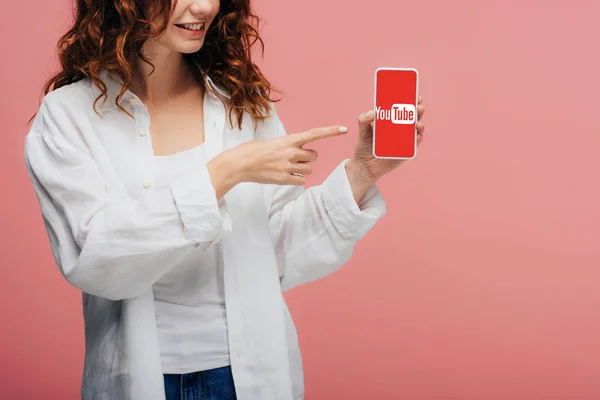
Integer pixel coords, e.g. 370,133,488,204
170,165,231,244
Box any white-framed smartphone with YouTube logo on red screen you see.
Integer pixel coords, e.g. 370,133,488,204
373,67,419,160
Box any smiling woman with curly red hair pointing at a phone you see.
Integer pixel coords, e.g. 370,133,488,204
25,0,423,400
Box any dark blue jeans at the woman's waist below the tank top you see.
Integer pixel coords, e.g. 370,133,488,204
164,367,237,400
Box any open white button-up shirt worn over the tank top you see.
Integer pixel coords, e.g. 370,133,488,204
25,73,385,400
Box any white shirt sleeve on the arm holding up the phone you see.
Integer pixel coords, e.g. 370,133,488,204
269,108,386,291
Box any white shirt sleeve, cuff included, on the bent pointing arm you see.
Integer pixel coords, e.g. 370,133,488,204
24,100,231,300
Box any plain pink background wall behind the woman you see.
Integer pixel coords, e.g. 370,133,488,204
0,0,600,400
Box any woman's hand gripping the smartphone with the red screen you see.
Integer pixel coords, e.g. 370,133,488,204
348,96,425,183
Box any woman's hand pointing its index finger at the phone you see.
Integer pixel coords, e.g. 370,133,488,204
207,125,348,198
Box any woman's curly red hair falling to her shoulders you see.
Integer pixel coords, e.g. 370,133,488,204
43,0,279,128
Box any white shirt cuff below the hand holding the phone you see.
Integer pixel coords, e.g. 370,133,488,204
323,159,386,239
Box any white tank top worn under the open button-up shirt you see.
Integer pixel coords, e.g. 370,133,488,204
154,145,230,374
